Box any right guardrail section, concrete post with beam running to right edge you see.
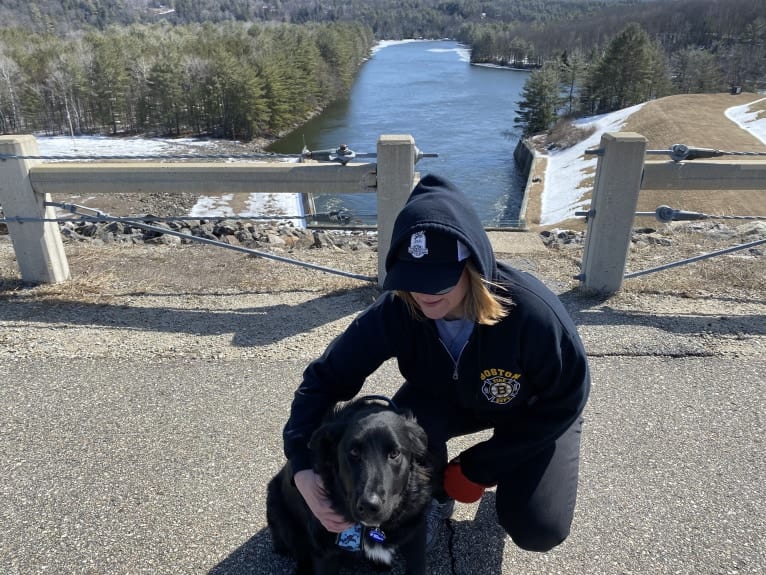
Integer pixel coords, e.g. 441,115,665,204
579,132,766,294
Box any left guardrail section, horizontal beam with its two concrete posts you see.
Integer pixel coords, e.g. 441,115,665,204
0,135,419,285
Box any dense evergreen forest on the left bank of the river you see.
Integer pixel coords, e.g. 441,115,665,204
0,22,374,140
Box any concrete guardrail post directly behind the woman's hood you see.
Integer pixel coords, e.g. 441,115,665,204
377,135,416,286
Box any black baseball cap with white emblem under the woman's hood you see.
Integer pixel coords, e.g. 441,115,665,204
383,230,471,295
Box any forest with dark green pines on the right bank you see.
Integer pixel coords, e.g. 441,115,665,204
498,0,766,135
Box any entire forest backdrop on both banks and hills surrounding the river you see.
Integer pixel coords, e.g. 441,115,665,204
0,0,766,138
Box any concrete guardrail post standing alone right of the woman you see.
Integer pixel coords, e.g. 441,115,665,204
581,132,646,294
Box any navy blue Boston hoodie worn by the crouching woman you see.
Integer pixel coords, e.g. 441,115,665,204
284,175,590,485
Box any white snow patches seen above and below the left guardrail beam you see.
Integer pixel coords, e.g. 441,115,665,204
37,136,305,227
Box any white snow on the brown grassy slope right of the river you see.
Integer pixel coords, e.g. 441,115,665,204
540,98,766,225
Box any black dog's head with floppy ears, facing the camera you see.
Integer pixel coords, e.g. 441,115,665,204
311,406,430,526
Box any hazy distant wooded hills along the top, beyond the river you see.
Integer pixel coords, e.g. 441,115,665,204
0,0,650,40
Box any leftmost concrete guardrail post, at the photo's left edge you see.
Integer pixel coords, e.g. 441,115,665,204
0,136,69,283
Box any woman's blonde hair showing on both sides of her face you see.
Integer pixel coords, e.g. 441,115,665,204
396,260,513,325
